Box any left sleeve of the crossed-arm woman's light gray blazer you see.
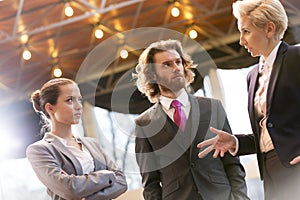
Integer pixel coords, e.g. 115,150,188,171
26,141,119,200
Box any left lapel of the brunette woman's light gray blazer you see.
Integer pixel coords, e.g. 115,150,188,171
44,133,83,174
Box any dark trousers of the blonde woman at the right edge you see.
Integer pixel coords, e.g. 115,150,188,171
264,150,300,200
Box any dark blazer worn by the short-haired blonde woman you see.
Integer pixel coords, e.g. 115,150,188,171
237,42,300,178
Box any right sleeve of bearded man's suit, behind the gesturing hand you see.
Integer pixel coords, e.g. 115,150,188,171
217,101,249,200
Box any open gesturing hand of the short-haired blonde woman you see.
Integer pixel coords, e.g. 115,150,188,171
197,127,236,158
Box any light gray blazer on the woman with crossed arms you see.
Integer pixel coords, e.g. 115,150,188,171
26,133,127,200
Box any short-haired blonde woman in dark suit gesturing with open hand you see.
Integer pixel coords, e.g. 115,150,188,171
198,0,300,200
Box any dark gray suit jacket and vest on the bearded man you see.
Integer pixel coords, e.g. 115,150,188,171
135,95,248,200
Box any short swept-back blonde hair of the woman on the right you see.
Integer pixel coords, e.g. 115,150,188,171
232,0,288,40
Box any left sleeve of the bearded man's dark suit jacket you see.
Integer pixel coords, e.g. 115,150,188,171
135,123,162,200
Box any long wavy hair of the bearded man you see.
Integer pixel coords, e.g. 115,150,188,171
133,39,196,103
